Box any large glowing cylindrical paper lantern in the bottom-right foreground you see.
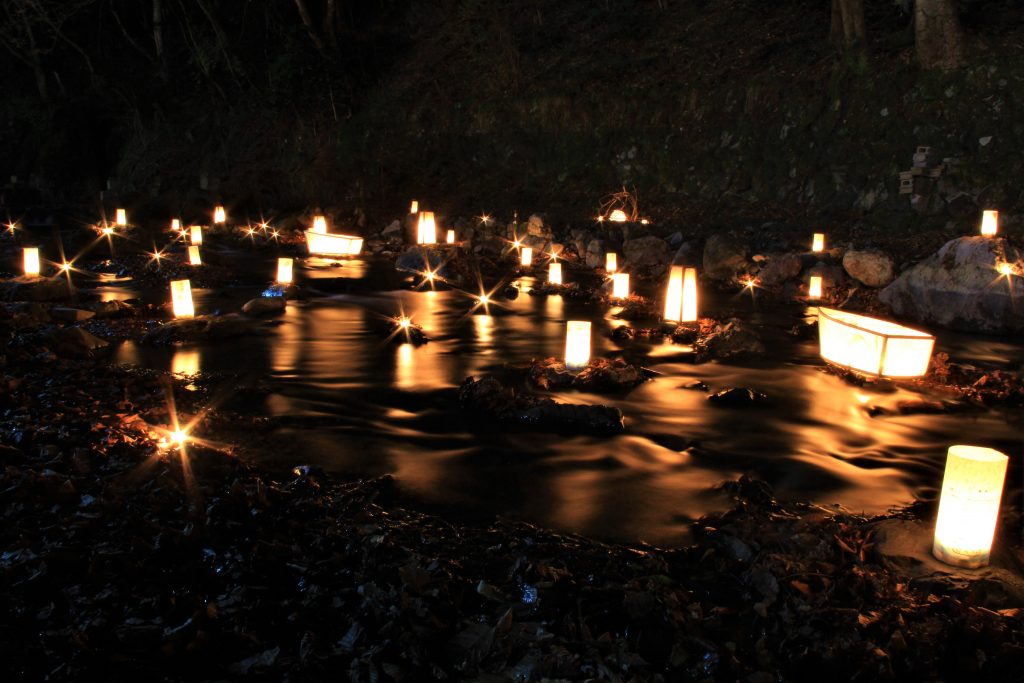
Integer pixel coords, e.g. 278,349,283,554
932,445,1010,568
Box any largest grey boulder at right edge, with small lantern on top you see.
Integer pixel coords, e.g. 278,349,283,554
879,236,1024,332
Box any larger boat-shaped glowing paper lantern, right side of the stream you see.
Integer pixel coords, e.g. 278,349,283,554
818,308,935,377
